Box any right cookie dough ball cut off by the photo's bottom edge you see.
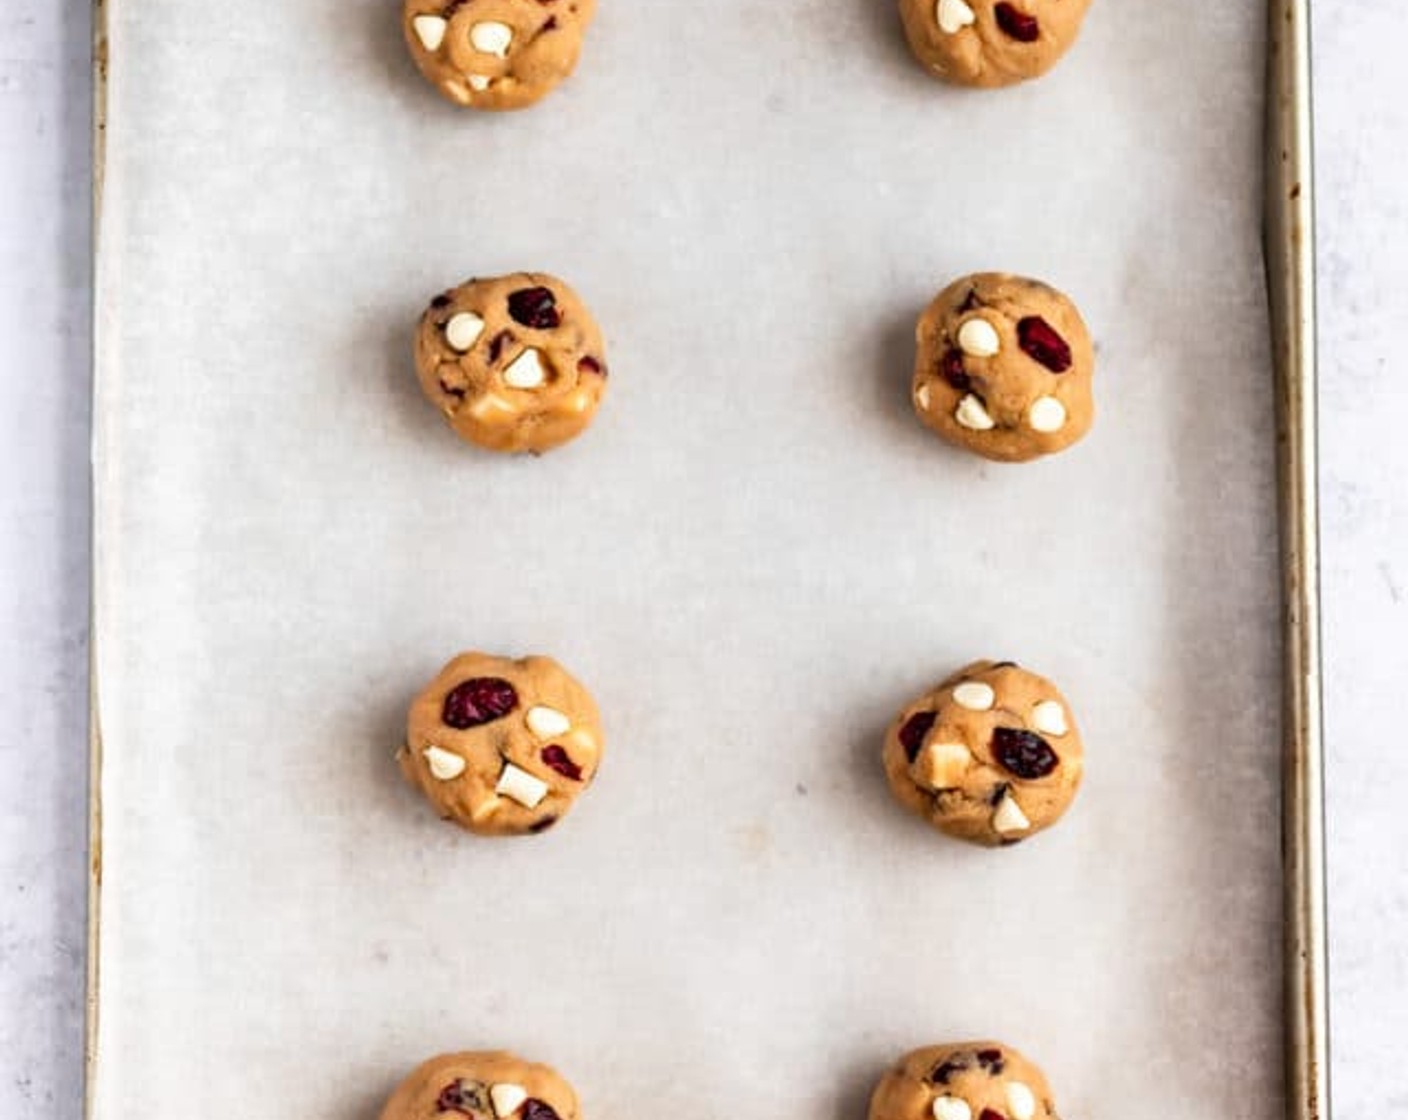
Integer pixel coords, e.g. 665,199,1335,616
870,1043,1057,1120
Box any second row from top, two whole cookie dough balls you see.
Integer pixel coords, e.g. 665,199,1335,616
415,272,1095,462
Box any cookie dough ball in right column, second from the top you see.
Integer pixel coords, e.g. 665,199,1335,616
914,272,1095,462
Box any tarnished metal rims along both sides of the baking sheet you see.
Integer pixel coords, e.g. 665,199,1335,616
84,0,1331,1120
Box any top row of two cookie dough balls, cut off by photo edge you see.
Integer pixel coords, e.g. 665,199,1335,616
403,0,1090,110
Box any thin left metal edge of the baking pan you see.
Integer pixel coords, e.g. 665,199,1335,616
83,0,108,1117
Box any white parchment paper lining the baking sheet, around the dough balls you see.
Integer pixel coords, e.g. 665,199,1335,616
82,0,1281,1120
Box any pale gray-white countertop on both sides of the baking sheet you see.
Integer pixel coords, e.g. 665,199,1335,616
0,0,1408,1120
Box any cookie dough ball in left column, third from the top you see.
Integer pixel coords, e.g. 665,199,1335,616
397,654,603,835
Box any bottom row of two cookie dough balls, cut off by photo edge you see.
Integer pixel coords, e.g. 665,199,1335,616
382,1041,1057,1120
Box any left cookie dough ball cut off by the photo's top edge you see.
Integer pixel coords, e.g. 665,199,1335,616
401,0,597,108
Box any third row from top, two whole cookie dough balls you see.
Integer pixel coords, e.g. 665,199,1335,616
397,654,1084,847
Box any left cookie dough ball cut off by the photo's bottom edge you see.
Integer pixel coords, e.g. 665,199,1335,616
382,1051,577,1120
